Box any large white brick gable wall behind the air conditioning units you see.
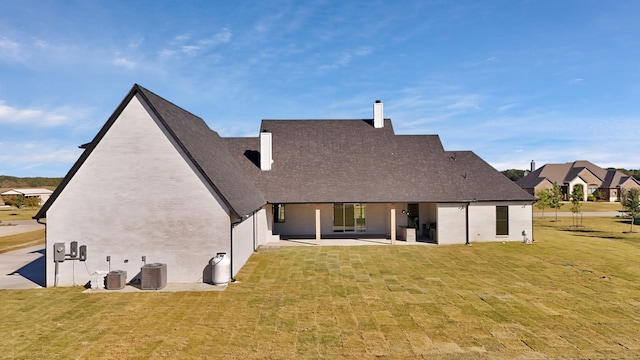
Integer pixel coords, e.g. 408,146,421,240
46,97,230,286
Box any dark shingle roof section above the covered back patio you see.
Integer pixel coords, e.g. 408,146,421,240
225,119,534,203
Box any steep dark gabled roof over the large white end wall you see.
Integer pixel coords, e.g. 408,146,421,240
34,84,265,219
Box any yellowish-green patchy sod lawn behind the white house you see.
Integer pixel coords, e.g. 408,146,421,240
0,218,640,359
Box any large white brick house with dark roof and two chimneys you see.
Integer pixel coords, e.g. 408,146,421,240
35,85,535,286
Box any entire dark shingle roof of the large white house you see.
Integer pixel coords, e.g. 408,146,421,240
35,85,534,219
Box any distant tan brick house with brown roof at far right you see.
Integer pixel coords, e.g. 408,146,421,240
516,160,640,202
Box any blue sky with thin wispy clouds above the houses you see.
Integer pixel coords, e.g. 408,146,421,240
0,0,640,177
